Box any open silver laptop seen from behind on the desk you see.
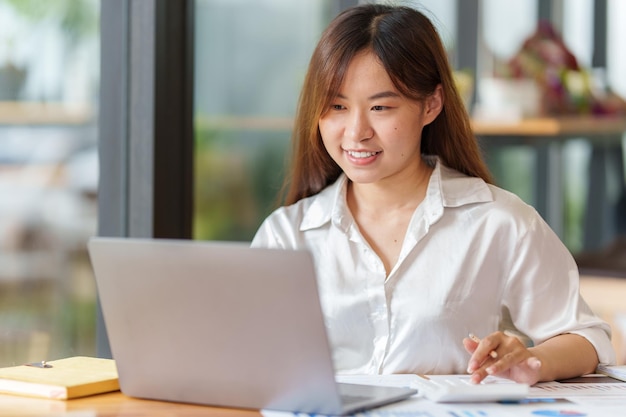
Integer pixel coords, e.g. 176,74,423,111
89,238,416,415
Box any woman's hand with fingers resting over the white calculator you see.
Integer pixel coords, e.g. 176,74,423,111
463,332,541,385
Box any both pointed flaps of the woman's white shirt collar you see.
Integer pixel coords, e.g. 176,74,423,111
300,156,493,231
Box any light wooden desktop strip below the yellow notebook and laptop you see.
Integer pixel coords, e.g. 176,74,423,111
0,391,261,417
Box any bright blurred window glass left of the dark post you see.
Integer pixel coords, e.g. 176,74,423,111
0,0,99,366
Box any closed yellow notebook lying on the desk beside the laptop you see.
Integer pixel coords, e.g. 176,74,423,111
0,356,120,400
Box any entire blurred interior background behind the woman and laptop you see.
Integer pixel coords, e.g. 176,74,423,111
0,0,626,366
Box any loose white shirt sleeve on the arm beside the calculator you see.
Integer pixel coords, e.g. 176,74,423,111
504,208,615,364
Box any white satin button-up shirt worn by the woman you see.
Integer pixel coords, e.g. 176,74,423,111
252,158,615,374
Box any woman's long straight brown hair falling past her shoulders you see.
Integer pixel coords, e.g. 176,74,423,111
283,4,492,204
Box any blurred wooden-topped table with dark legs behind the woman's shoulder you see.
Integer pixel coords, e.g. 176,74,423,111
472,116,626,249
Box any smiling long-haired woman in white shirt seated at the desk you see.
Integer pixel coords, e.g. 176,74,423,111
252,5,614,384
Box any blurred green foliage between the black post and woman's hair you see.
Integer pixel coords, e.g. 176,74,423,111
193,123,289,241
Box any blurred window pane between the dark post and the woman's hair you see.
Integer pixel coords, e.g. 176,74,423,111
193,0,338,241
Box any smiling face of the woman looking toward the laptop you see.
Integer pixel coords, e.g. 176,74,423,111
319,51,442,184
